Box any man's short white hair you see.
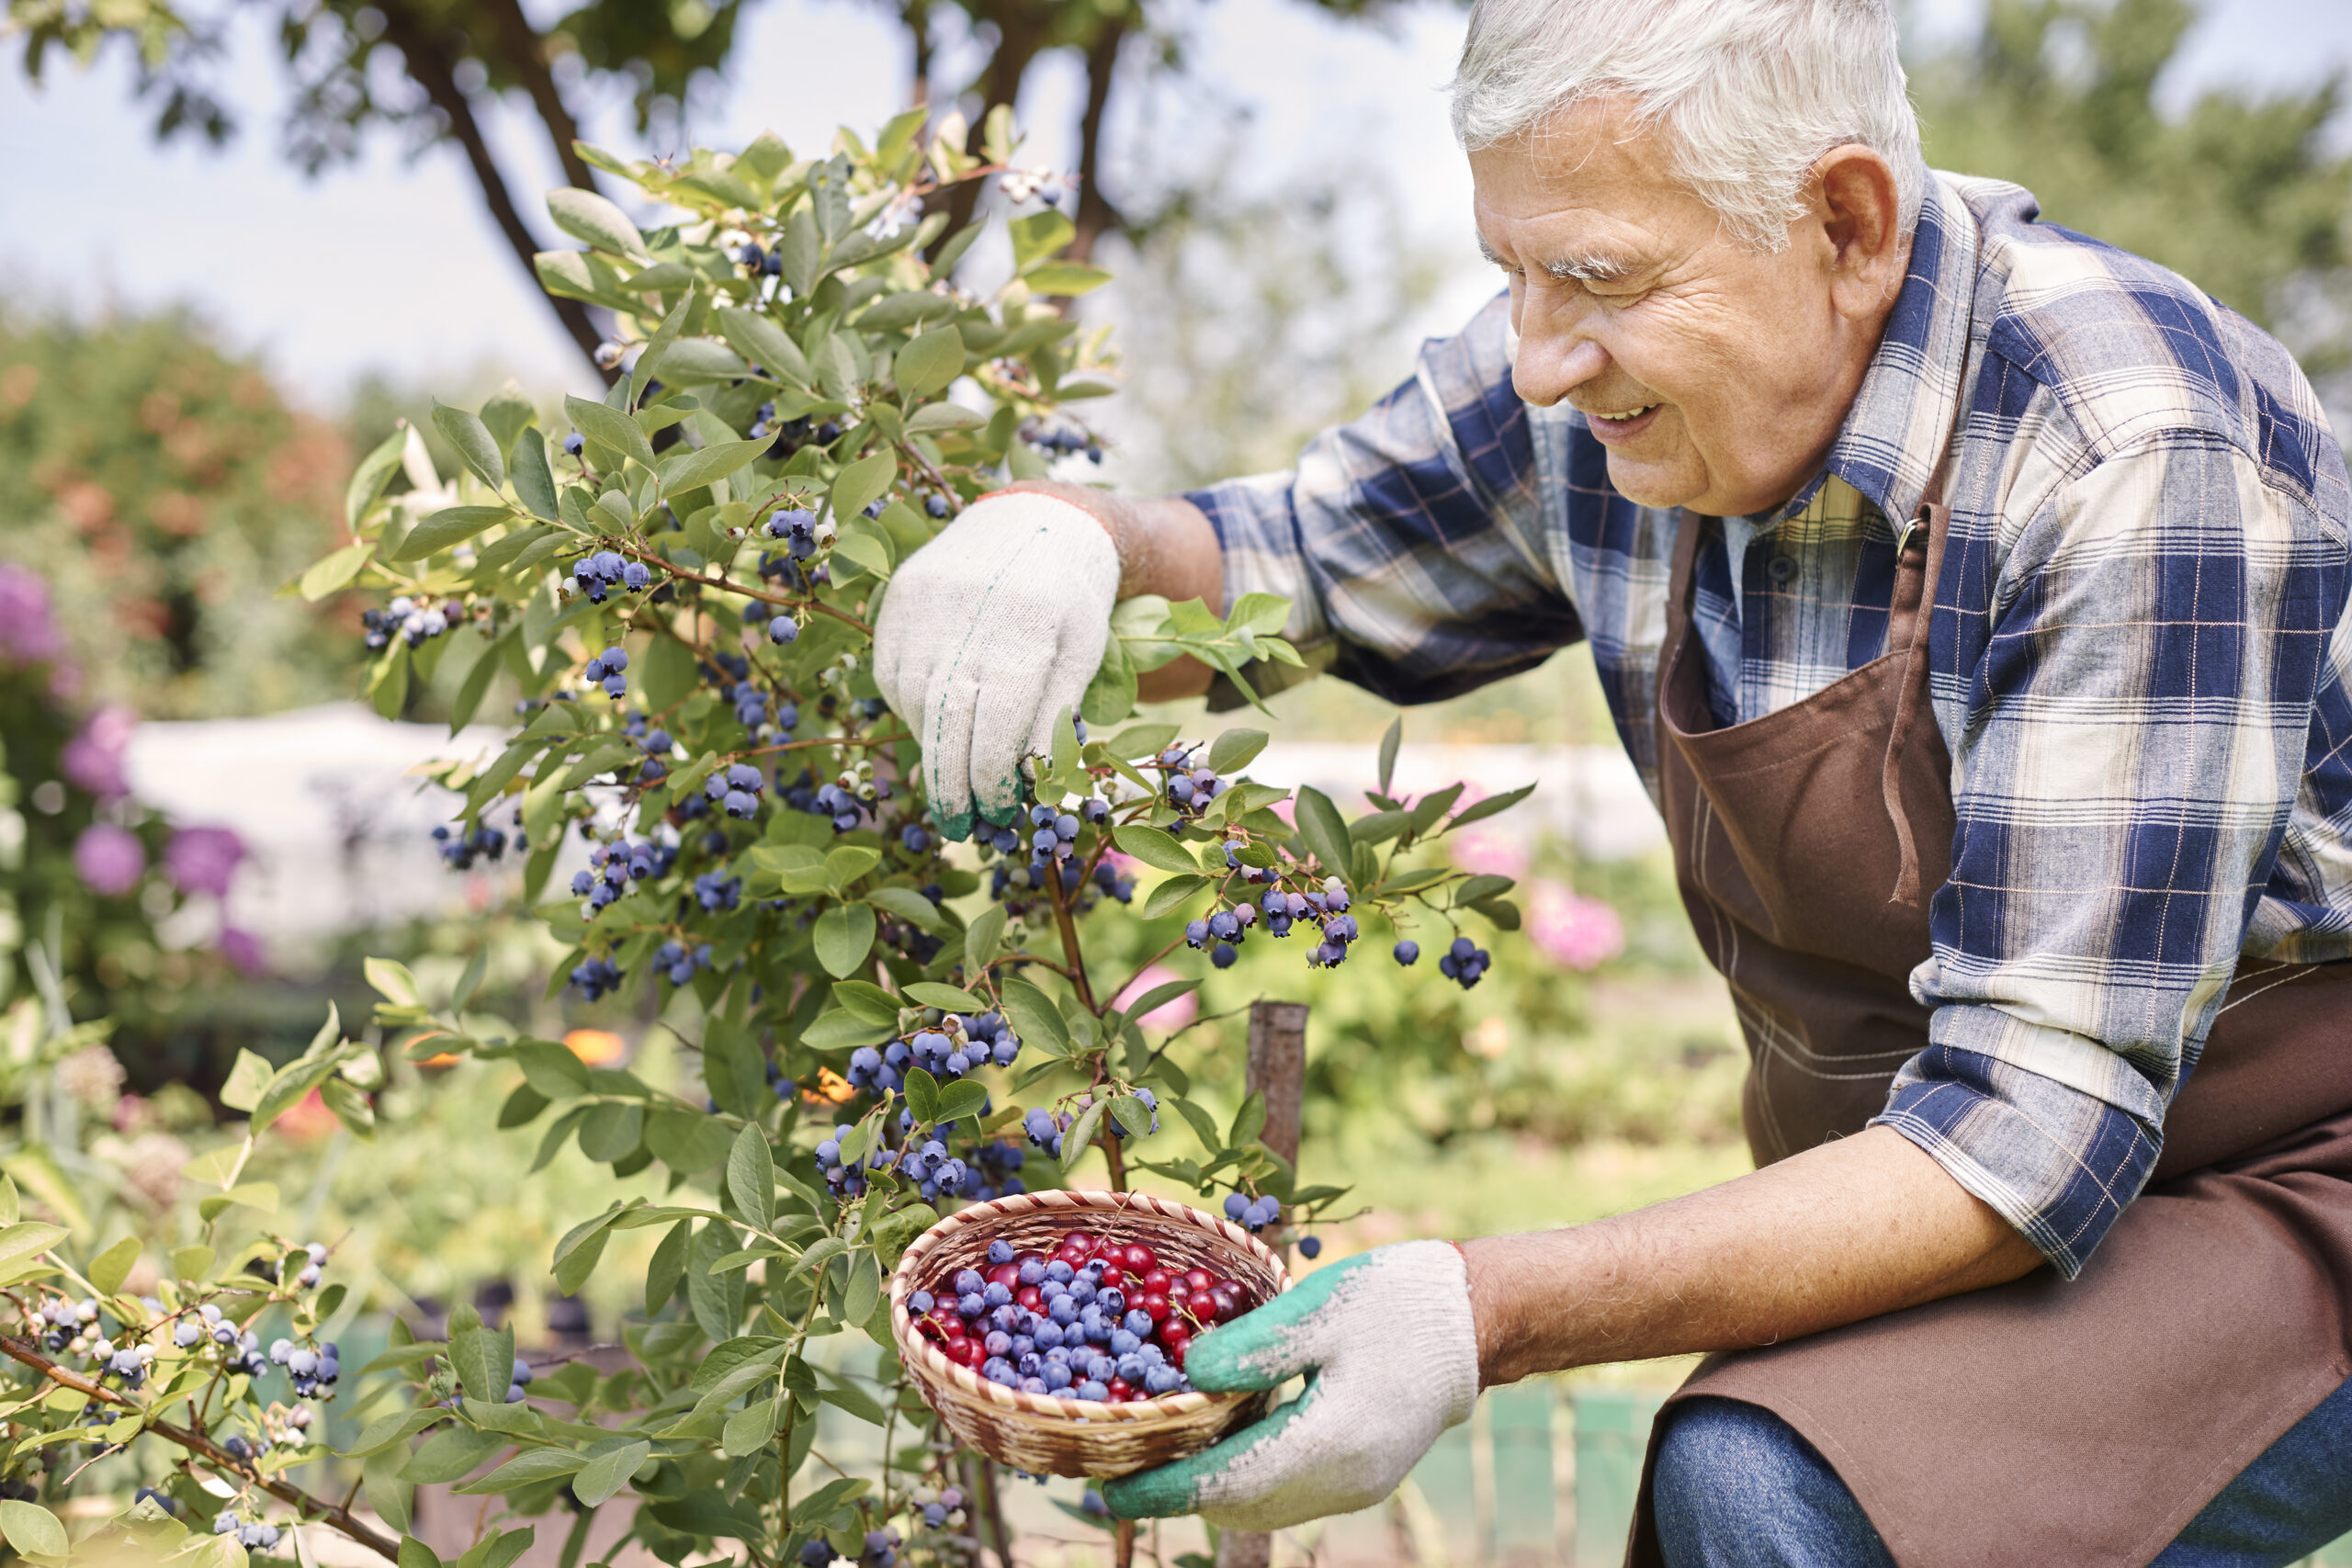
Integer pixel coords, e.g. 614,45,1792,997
1452,0,1927,252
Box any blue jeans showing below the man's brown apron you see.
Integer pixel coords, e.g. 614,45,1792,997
1651,1382,2352,1568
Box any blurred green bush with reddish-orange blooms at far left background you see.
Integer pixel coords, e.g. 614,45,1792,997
0,312,360,719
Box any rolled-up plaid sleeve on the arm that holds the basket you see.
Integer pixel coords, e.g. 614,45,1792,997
1877,434,2347,1277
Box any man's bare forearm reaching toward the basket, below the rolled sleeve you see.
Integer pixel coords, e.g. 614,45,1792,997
1463,1126,2041,1384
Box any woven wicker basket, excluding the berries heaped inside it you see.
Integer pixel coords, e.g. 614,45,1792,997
889,1190,1291,1479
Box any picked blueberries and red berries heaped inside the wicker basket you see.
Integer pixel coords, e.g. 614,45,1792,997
908,1232,1244,1404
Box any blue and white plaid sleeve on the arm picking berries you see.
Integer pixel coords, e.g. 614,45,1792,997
1188,299,1583,703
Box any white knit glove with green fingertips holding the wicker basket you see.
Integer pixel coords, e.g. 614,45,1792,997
1103,1241,1477,1530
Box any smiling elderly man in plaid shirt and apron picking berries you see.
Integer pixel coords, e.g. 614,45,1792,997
877,0,2352,1568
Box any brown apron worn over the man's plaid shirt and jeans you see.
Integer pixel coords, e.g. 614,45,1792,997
1628,495,2352,1568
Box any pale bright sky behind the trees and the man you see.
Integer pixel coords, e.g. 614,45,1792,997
0,0,2352,407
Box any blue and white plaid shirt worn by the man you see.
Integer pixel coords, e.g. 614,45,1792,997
1193,176,2352,1277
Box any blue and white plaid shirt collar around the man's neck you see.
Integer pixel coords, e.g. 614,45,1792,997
1773,172,1978,522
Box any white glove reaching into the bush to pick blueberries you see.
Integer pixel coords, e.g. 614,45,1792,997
875,491,1120,840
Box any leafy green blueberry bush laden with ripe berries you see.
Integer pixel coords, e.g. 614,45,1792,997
0,113,1517,1568
